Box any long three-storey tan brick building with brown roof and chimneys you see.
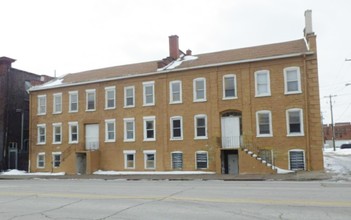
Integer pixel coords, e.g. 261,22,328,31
30,11,323,174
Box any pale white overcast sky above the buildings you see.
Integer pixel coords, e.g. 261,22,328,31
0,0,351,123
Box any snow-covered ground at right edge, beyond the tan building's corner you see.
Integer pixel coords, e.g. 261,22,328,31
324,149,351,181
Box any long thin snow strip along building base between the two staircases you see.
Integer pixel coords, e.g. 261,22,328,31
94,170,215,175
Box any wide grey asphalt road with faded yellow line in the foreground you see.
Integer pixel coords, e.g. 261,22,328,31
0,179,351,220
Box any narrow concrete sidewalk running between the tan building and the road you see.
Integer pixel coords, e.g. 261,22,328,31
0,172,332,181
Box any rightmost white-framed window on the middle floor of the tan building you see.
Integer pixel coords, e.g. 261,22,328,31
286,108,304,136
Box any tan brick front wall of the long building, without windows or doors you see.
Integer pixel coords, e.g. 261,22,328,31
30,52,323,173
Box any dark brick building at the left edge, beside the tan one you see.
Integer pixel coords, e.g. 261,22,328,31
0,57,48,170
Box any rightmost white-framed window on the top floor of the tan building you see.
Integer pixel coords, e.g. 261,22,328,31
284,67,301,94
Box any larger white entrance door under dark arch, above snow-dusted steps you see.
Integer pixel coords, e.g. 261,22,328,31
221,116,240,149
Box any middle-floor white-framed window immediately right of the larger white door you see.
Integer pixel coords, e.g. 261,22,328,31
256,110,273,137
